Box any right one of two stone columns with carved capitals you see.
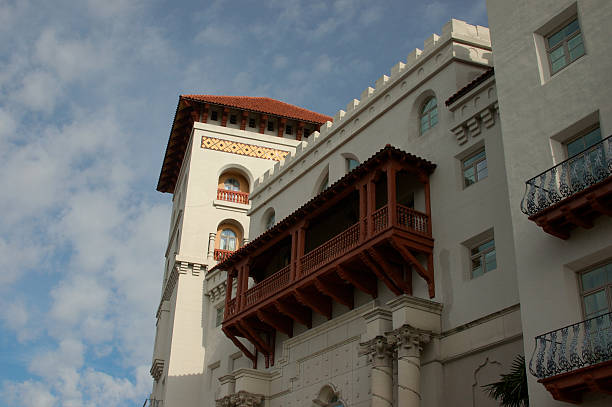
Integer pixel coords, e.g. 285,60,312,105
389,324,431,407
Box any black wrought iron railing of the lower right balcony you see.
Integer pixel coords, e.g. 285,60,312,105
529,312,612,379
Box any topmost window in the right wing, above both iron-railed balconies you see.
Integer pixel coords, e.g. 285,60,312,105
546,17,584,74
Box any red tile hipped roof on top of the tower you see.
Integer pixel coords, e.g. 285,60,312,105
181,95,332,124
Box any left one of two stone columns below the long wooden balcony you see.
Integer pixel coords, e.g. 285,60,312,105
360,335,393,407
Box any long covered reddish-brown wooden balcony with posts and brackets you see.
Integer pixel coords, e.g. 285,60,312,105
215,146,435,366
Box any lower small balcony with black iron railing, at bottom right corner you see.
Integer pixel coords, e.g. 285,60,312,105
529,313,612,404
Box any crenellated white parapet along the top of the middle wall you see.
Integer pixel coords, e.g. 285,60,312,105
250,19,492,211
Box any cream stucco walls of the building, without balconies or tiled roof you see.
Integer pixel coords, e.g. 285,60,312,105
150,0,612,407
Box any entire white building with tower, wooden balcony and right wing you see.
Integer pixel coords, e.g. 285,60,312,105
150,0,612,407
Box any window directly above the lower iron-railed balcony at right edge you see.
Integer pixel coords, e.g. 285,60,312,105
580,262,612,319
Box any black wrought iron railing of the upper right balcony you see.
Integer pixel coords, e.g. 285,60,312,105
521,136,612,216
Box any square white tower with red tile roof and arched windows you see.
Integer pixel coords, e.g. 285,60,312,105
150,95,331,406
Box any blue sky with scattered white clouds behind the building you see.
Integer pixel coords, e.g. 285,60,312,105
0,0,487,407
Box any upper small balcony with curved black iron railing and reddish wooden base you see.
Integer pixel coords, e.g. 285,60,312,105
521,136,612,239
